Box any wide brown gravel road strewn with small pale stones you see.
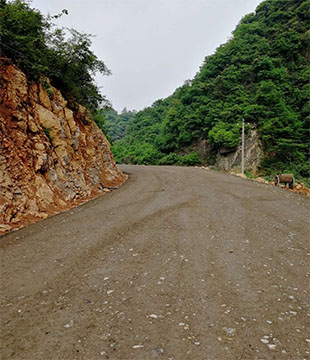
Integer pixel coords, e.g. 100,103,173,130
0,166,310,360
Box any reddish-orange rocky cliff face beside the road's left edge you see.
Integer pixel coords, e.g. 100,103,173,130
0,59,126,233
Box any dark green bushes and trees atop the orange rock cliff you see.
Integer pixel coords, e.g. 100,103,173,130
0,0,110,109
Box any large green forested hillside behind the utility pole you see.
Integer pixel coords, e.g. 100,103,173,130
112,0,310,177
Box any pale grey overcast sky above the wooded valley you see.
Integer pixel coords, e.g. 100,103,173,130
32,0,262,111
